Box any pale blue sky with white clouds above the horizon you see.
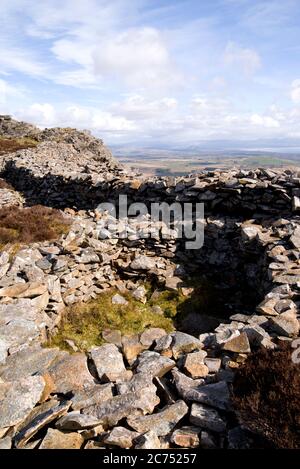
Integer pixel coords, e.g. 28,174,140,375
0,0,300,147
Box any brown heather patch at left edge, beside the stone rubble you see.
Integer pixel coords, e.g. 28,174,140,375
0,205,69,247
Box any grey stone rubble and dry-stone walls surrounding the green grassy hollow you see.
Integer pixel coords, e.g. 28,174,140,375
0,117,300,449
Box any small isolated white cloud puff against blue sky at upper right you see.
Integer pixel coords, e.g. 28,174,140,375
224,41,261,75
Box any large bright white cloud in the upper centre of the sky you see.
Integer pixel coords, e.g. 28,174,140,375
51,27,181,89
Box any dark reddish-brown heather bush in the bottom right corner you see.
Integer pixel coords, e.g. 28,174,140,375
233,347,300,449
